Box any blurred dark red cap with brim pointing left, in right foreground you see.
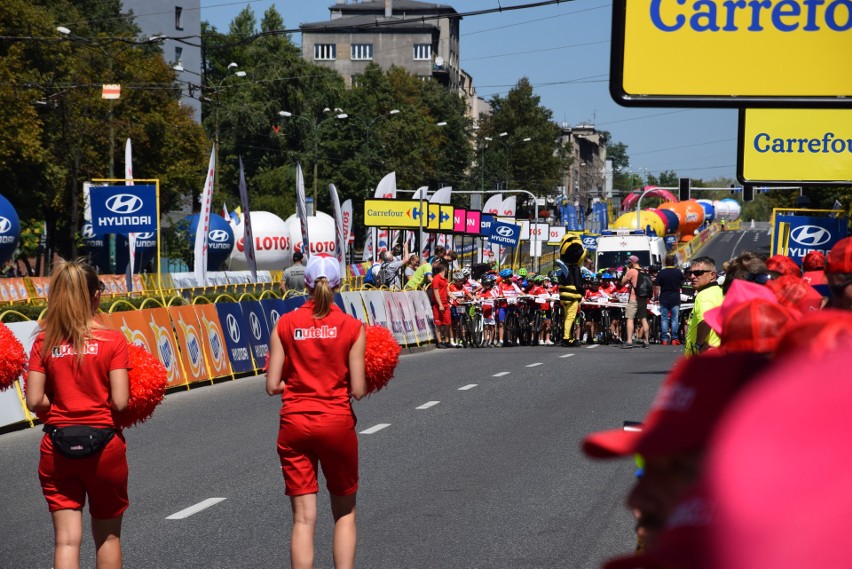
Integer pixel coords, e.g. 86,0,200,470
583,352,767,458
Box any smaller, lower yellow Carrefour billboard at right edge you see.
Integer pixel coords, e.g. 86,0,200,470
737,108,852,182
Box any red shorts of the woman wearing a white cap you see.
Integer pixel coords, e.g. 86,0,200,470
278,413,358,496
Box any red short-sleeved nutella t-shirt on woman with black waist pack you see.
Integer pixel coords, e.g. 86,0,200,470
29,330,130,427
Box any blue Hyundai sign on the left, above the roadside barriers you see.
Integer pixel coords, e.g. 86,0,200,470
89,186,157,235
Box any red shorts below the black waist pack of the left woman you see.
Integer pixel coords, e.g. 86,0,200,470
38,433,130,520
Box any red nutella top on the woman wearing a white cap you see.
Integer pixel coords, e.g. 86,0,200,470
276,300,361,415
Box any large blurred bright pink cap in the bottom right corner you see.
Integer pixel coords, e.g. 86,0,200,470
707,349,852,569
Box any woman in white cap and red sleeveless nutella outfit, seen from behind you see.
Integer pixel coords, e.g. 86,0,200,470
266,255,367,569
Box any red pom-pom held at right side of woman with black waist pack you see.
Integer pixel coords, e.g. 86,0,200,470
114,344,169,427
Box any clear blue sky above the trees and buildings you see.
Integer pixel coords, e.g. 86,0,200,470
201,0,737,184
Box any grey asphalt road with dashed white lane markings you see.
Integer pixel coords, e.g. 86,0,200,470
0,231,757,569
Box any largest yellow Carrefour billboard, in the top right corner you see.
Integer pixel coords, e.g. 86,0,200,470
610,0,852,107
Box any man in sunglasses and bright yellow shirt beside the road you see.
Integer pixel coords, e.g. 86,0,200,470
683,257,725,357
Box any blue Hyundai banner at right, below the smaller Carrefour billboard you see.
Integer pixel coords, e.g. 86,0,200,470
772,215,847,265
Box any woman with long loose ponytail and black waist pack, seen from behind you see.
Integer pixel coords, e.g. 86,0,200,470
27,259,130,569
